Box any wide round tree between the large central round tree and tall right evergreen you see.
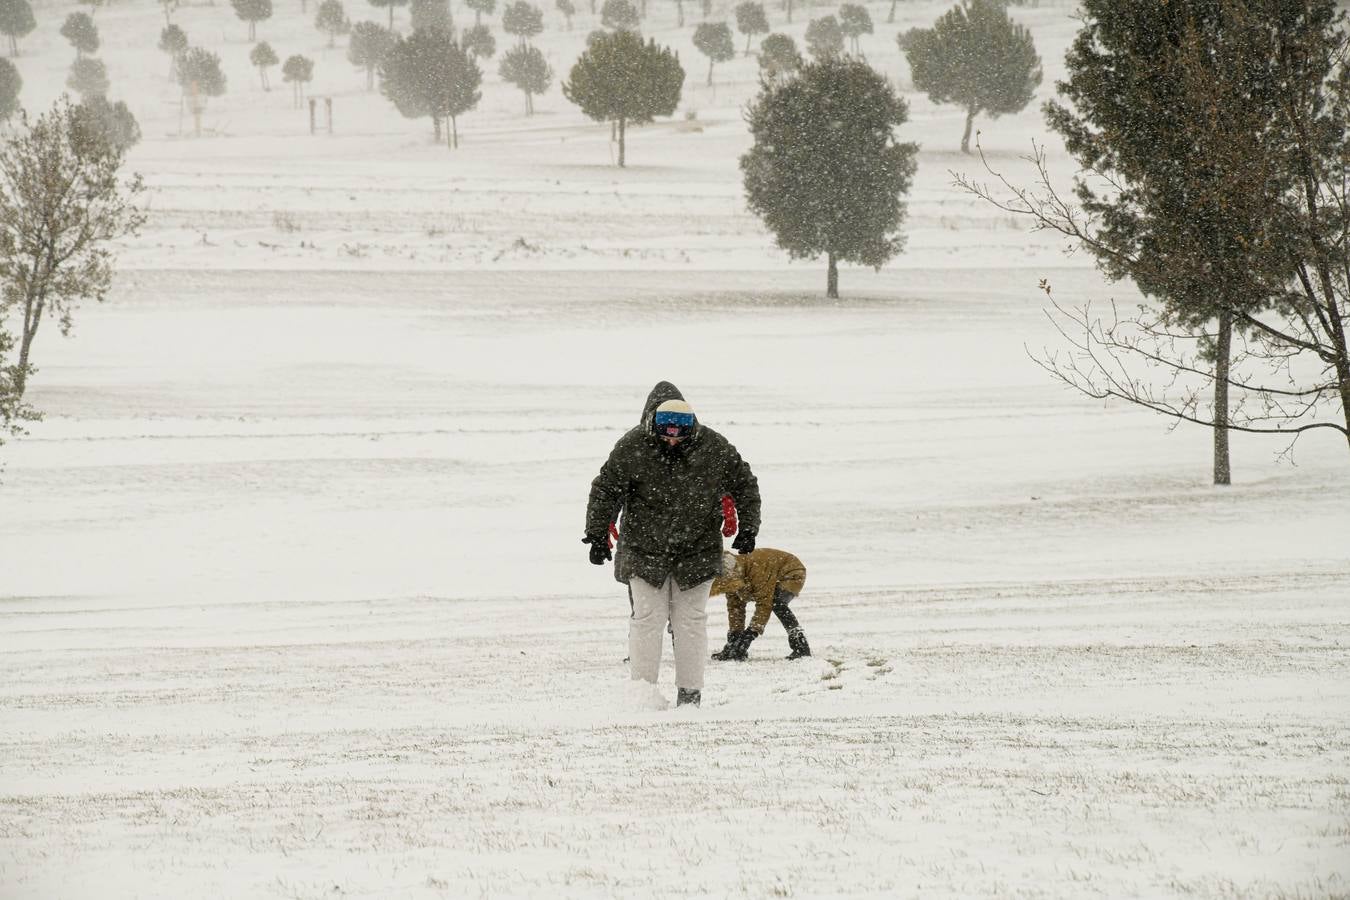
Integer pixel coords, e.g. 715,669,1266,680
905,0,1042,152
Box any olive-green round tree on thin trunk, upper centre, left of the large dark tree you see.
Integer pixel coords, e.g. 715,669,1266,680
563,29,684,167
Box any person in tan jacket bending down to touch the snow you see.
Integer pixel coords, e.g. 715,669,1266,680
711,546,811,660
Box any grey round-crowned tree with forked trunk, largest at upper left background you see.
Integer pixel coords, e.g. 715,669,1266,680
379,28,483,147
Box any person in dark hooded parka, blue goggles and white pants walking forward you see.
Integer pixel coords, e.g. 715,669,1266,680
582,382,760,704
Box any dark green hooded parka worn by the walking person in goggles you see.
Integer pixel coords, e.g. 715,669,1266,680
586,382,760,588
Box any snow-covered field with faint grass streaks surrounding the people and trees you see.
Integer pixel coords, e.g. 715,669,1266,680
0,1,1350,900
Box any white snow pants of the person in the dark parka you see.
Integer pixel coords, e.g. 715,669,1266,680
628,576,713,691
